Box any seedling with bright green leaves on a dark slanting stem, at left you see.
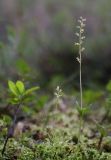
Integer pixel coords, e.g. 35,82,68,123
2,81,39,155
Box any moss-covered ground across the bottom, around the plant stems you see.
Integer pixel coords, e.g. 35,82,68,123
0,94,111,160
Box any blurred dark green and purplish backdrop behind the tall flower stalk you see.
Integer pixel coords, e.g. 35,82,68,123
0,0,111,89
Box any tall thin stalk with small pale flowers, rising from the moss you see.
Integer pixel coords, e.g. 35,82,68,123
75,17,87,139
